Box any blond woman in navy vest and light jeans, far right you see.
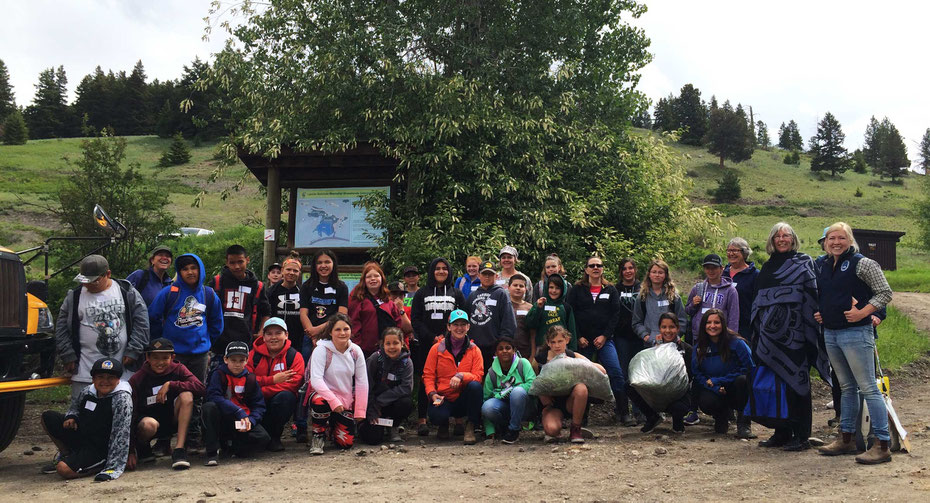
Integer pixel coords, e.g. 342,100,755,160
814,222,891,464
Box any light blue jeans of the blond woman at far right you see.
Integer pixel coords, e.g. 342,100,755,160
823,325,891,440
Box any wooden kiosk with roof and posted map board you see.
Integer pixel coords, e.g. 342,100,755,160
239,143,399,273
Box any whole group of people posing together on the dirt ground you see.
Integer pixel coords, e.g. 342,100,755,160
42,222,891,480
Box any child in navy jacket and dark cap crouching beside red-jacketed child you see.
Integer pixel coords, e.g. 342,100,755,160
203,341,271,466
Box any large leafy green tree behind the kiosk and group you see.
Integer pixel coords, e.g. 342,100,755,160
208,0,716,274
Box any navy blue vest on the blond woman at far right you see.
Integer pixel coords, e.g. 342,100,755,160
817,248,873,330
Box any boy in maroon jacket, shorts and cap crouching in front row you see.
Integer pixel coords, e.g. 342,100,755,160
128,338,206,470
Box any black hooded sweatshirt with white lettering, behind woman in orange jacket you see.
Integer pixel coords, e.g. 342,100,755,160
410,257,465,347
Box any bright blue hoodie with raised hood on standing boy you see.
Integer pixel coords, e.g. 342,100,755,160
149,253,223,355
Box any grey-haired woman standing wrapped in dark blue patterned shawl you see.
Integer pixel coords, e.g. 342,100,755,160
751,222,830,451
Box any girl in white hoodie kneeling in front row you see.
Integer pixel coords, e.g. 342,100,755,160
305,313,368,455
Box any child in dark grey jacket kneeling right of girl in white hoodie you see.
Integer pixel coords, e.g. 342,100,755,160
359,327,413,445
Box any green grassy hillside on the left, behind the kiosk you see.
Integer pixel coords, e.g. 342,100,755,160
0,136,264,249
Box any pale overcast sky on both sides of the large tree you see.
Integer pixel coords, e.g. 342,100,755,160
0,0,930,161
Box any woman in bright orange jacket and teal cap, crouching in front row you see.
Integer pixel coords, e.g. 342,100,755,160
423,309,484,445
